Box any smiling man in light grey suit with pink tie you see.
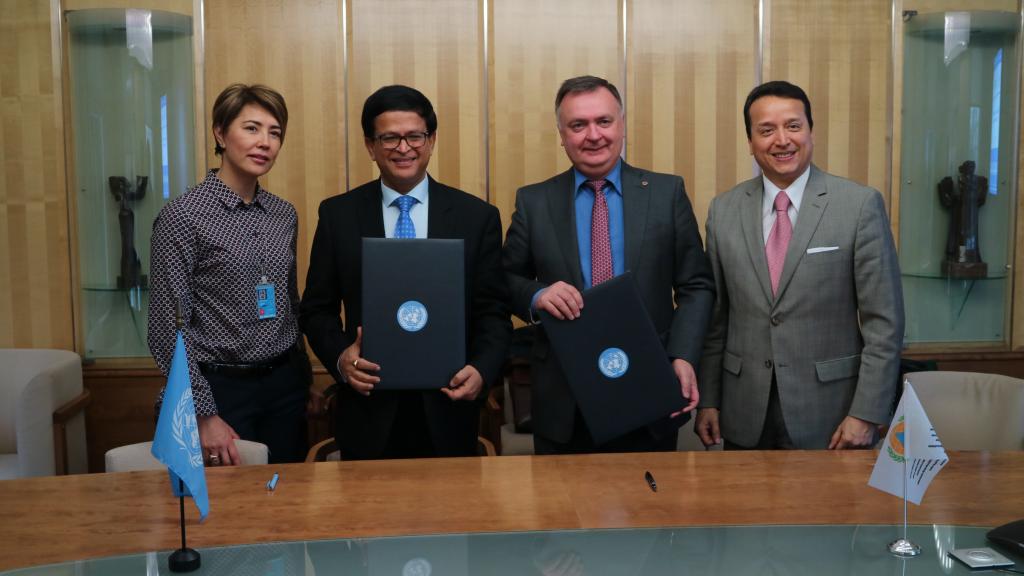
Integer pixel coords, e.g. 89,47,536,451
694,81,903,449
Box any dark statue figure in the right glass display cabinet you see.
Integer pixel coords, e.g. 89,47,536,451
939,160,988,278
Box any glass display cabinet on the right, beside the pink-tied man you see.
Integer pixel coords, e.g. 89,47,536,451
897,10,1021,342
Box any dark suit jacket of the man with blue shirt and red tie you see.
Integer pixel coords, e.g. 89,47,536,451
503,162,715,443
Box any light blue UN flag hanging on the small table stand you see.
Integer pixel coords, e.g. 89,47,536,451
153,330,210,522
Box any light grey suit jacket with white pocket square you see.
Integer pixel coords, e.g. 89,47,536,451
697,166,903,449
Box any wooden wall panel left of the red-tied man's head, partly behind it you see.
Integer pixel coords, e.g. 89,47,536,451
489,0,628,228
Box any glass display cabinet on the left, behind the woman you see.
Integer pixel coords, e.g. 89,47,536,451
65,9,196,358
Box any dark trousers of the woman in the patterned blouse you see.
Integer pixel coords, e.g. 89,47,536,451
204,354,309,463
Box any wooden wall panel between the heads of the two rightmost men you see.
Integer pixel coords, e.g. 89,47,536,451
627,0,758,231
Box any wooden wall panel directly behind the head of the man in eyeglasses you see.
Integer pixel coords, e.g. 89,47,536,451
348,0,486,198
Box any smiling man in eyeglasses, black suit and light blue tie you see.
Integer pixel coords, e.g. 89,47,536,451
299,86,512,460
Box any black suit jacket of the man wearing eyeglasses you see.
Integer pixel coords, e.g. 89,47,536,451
299,178,512,459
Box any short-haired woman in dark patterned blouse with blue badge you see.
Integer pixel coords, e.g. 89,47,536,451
148,84,310,465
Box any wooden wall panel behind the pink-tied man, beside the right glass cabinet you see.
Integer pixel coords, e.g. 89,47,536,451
764,0,891,201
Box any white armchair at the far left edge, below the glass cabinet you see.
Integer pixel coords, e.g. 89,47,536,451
0,348,89,480
